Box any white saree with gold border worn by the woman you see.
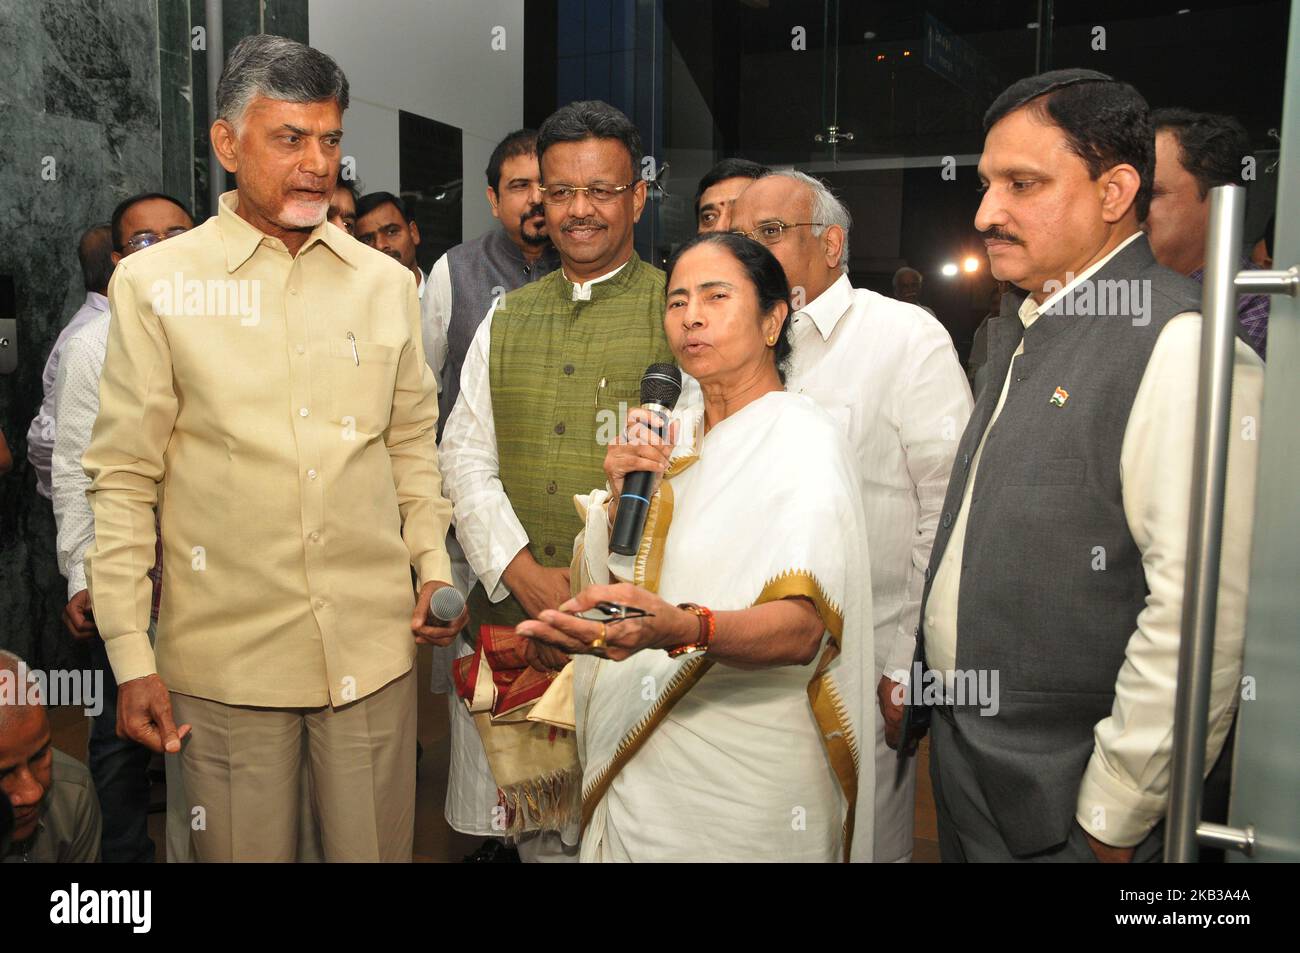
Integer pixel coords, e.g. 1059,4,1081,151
572,391,875,862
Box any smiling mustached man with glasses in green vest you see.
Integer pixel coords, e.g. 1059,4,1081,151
438,101,672,861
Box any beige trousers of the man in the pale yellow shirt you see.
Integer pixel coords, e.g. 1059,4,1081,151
172,668,416,862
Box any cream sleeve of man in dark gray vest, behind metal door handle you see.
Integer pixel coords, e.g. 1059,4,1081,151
1075,313,1264,846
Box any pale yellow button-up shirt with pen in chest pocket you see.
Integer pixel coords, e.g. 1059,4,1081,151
82,192,451,707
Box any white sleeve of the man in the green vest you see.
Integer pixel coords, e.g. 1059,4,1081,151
438,304,528,602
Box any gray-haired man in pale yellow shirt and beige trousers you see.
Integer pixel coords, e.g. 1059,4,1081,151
83,35,464,861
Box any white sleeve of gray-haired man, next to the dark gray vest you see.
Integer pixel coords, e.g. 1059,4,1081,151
881,319,972,684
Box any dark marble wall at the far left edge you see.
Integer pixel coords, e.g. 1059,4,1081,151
0,0,163,667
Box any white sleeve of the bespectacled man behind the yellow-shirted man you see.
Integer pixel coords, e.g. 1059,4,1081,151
51,327,104,599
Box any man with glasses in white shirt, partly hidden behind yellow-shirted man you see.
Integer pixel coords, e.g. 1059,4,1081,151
51,192,194,863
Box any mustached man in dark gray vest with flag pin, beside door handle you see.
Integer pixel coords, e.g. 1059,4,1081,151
910,69,1264,862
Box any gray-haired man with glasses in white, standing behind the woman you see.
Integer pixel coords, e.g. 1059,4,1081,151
732,172,971,862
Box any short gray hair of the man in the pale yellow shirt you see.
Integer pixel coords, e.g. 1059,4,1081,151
217,33,347,126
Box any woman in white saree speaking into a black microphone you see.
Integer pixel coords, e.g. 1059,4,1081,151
517,234,874,861
